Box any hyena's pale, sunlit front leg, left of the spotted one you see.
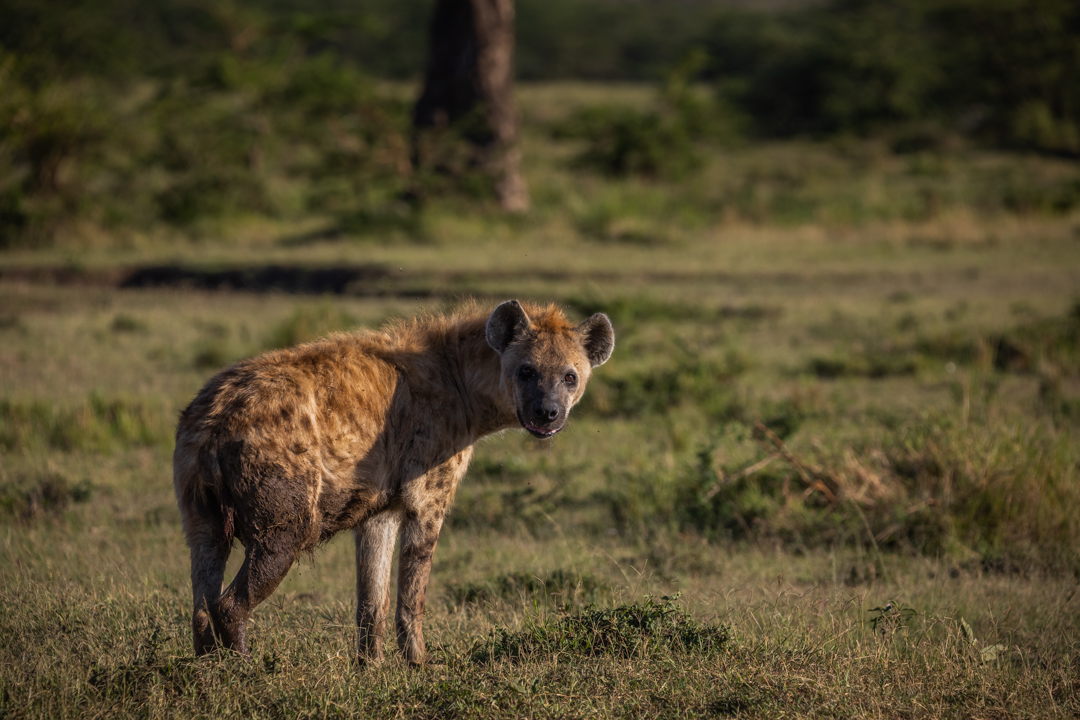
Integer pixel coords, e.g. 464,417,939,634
355,511,402,665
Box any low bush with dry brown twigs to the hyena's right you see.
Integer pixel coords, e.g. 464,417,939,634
607,416,1080,571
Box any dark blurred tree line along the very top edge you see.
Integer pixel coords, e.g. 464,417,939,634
0,0,1080,151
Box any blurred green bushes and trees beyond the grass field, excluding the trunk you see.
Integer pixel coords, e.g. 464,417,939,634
0,0,1080,248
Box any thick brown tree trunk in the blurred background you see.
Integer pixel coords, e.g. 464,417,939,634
413,0,529,212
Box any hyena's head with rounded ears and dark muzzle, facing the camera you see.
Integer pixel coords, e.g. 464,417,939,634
487,300,615,437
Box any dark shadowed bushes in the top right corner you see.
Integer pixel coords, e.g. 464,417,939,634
705,0,1080,153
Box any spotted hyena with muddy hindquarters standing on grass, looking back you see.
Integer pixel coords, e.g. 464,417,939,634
173,300,615,663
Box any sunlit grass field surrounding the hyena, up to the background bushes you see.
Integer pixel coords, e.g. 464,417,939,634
0,86,1080,718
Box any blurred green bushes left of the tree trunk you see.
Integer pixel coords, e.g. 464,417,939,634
0,35,414,246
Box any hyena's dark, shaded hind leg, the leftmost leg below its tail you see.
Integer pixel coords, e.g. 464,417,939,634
184,513,232,655
